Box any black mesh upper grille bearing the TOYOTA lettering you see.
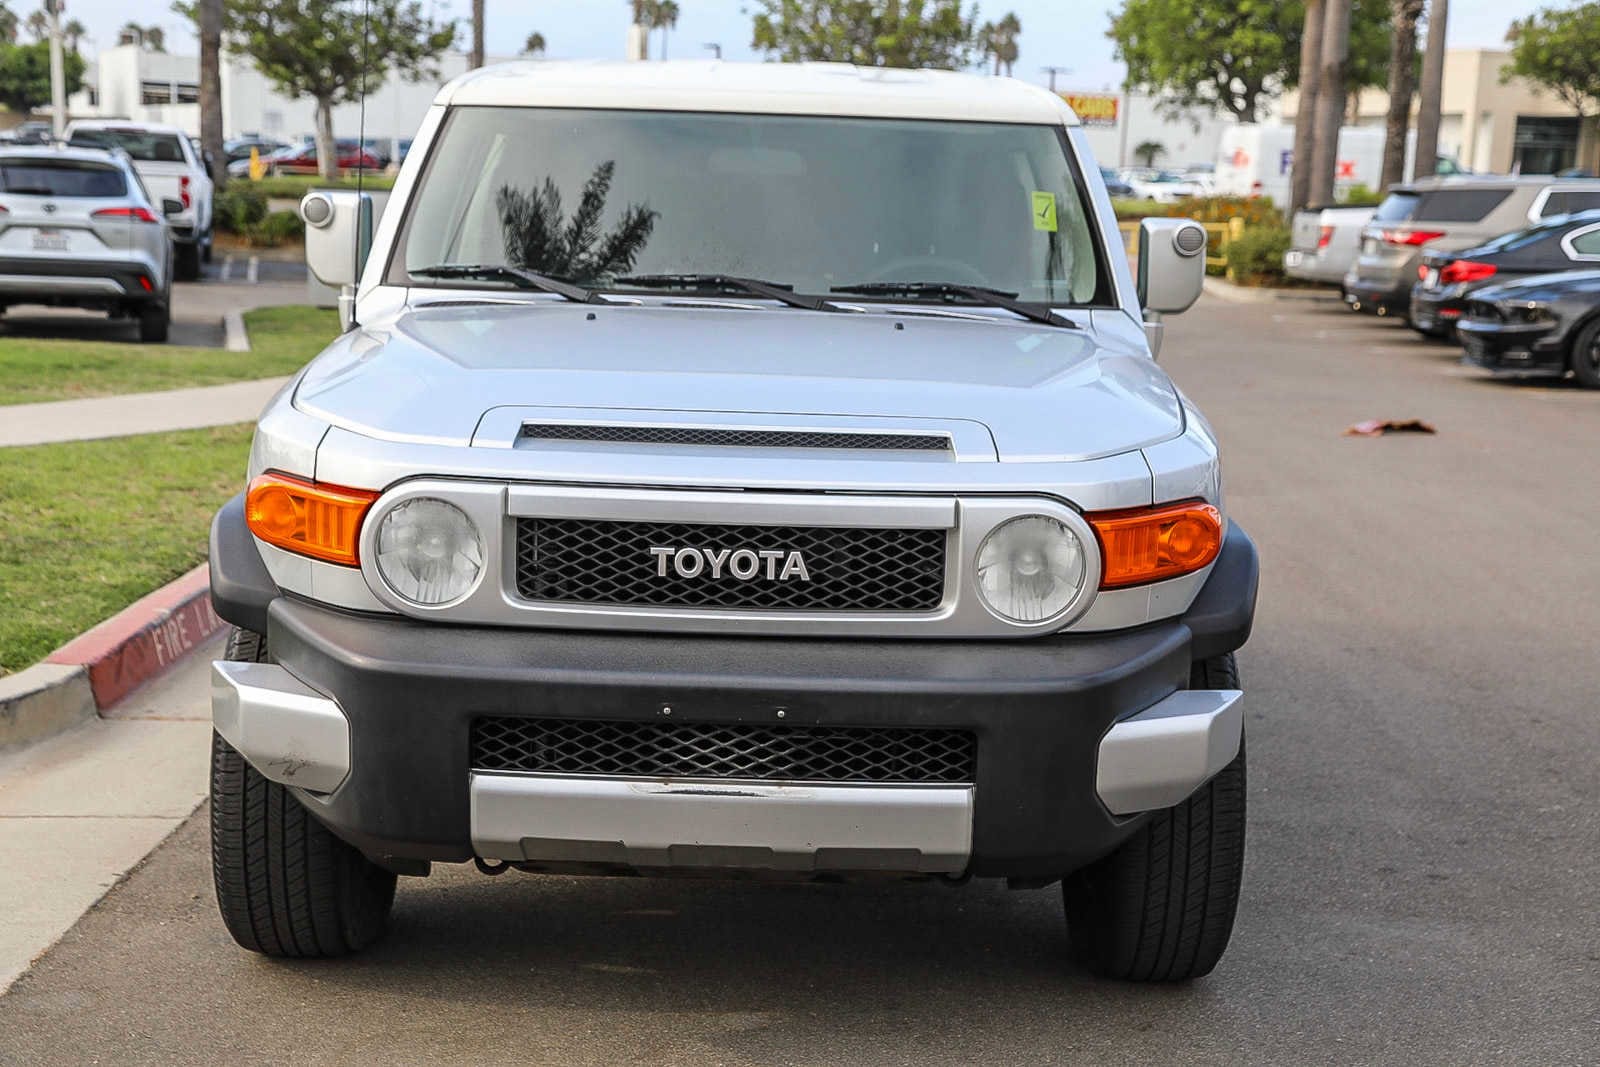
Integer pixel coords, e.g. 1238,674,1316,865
517,518,947,611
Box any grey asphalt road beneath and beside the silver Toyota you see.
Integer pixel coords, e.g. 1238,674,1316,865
0,298,1600,1067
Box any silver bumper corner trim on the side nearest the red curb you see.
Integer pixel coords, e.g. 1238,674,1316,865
211,661,350,793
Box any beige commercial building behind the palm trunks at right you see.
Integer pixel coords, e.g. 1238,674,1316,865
1278,48,1600,174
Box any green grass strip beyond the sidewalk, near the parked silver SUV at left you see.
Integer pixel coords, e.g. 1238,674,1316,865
0,307,339,405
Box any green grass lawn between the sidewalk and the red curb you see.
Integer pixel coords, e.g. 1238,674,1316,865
0,424,251,675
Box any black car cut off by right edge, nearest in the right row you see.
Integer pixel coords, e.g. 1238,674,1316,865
1456,270,1600,389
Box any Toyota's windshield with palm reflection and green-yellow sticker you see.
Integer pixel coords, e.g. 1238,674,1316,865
390,107,1110,306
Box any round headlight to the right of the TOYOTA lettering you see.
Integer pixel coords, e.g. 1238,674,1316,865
978,515,1086,624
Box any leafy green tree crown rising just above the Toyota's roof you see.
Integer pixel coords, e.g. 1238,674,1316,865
750,0,979,70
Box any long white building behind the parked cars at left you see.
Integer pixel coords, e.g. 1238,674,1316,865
67,45,507,141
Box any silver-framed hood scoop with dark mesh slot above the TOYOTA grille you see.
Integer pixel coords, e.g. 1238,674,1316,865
472,406,997,462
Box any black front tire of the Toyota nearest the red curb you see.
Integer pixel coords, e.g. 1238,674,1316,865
211,629,395,958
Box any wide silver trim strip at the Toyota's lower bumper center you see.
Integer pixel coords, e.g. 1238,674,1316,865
472,773,973,873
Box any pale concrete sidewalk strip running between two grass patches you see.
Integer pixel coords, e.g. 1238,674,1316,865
0,378,288,448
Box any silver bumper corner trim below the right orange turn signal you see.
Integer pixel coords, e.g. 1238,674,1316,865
1094,689,1245,814
